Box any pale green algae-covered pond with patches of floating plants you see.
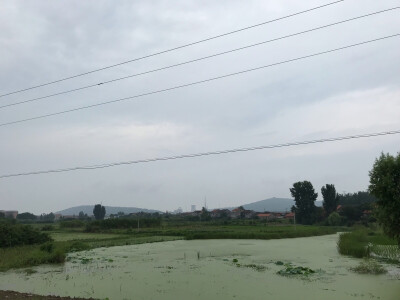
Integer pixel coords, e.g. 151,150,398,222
0,235,400,300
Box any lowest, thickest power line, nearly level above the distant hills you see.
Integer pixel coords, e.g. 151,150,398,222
0,130,400,179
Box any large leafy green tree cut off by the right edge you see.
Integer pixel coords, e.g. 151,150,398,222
369,153,400,248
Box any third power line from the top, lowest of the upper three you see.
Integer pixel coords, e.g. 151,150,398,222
0,34,400,127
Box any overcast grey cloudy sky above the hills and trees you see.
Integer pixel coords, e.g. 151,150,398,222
0,0,400,214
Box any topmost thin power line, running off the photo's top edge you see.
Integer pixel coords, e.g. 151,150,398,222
0,0,344,98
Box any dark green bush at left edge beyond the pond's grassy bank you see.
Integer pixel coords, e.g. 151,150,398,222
0,222,51,248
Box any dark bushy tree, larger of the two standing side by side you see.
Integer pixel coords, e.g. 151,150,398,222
290,181,318,224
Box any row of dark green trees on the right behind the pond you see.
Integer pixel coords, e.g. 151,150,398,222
290,153,400,247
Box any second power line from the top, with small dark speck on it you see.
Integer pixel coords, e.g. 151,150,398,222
0,7,400,109
